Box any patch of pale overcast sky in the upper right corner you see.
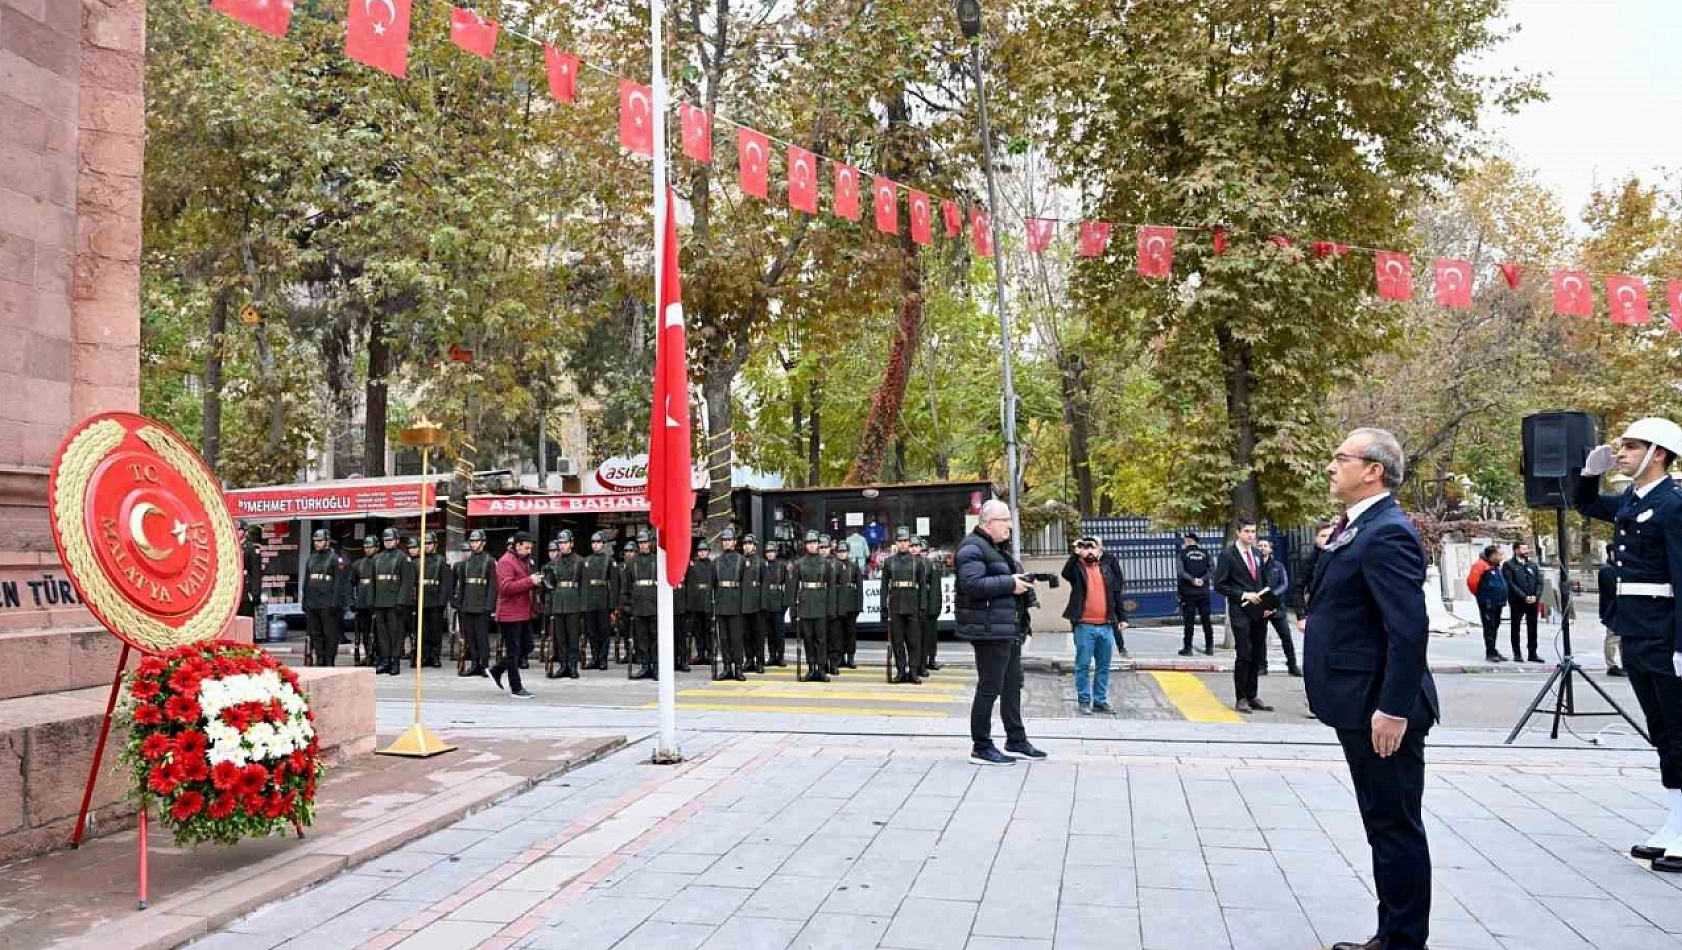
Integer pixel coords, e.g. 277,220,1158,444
1487,0,1682,222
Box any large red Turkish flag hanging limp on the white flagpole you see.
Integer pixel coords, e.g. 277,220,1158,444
646,187,695,585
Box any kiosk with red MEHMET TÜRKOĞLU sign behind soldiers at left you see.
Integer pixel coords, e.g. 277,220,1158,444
224,472,451,637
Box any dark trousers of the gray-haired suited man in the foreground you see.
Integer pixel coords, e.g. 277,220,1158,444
1337,716,1431,950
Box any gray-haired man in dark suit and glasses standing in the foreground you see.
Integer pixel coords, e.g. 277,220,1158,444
1304,429,1438,950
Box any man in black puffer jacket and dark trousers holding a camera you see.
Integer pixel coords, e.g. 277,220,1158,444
952,499,1046,765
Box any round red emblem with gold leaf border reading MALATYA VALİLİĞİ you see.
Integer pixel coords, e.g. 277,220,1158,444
47,412,242,652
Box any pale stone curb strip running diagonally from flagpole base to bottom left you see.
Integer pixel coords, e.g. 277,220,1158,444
54,736,629,950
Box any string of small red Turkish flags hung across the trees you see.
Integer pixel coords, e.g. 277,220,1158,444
210,0,1682,331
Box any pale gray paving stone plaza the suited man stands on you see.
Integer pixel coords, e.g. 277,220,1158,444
180,721,1682,950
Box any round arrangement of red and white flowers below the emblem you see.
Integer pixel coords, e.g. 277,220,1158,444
123,642,321,844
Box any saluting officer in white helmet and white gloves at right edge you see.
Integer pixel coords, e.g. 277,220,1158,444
1574,419,1682,871
